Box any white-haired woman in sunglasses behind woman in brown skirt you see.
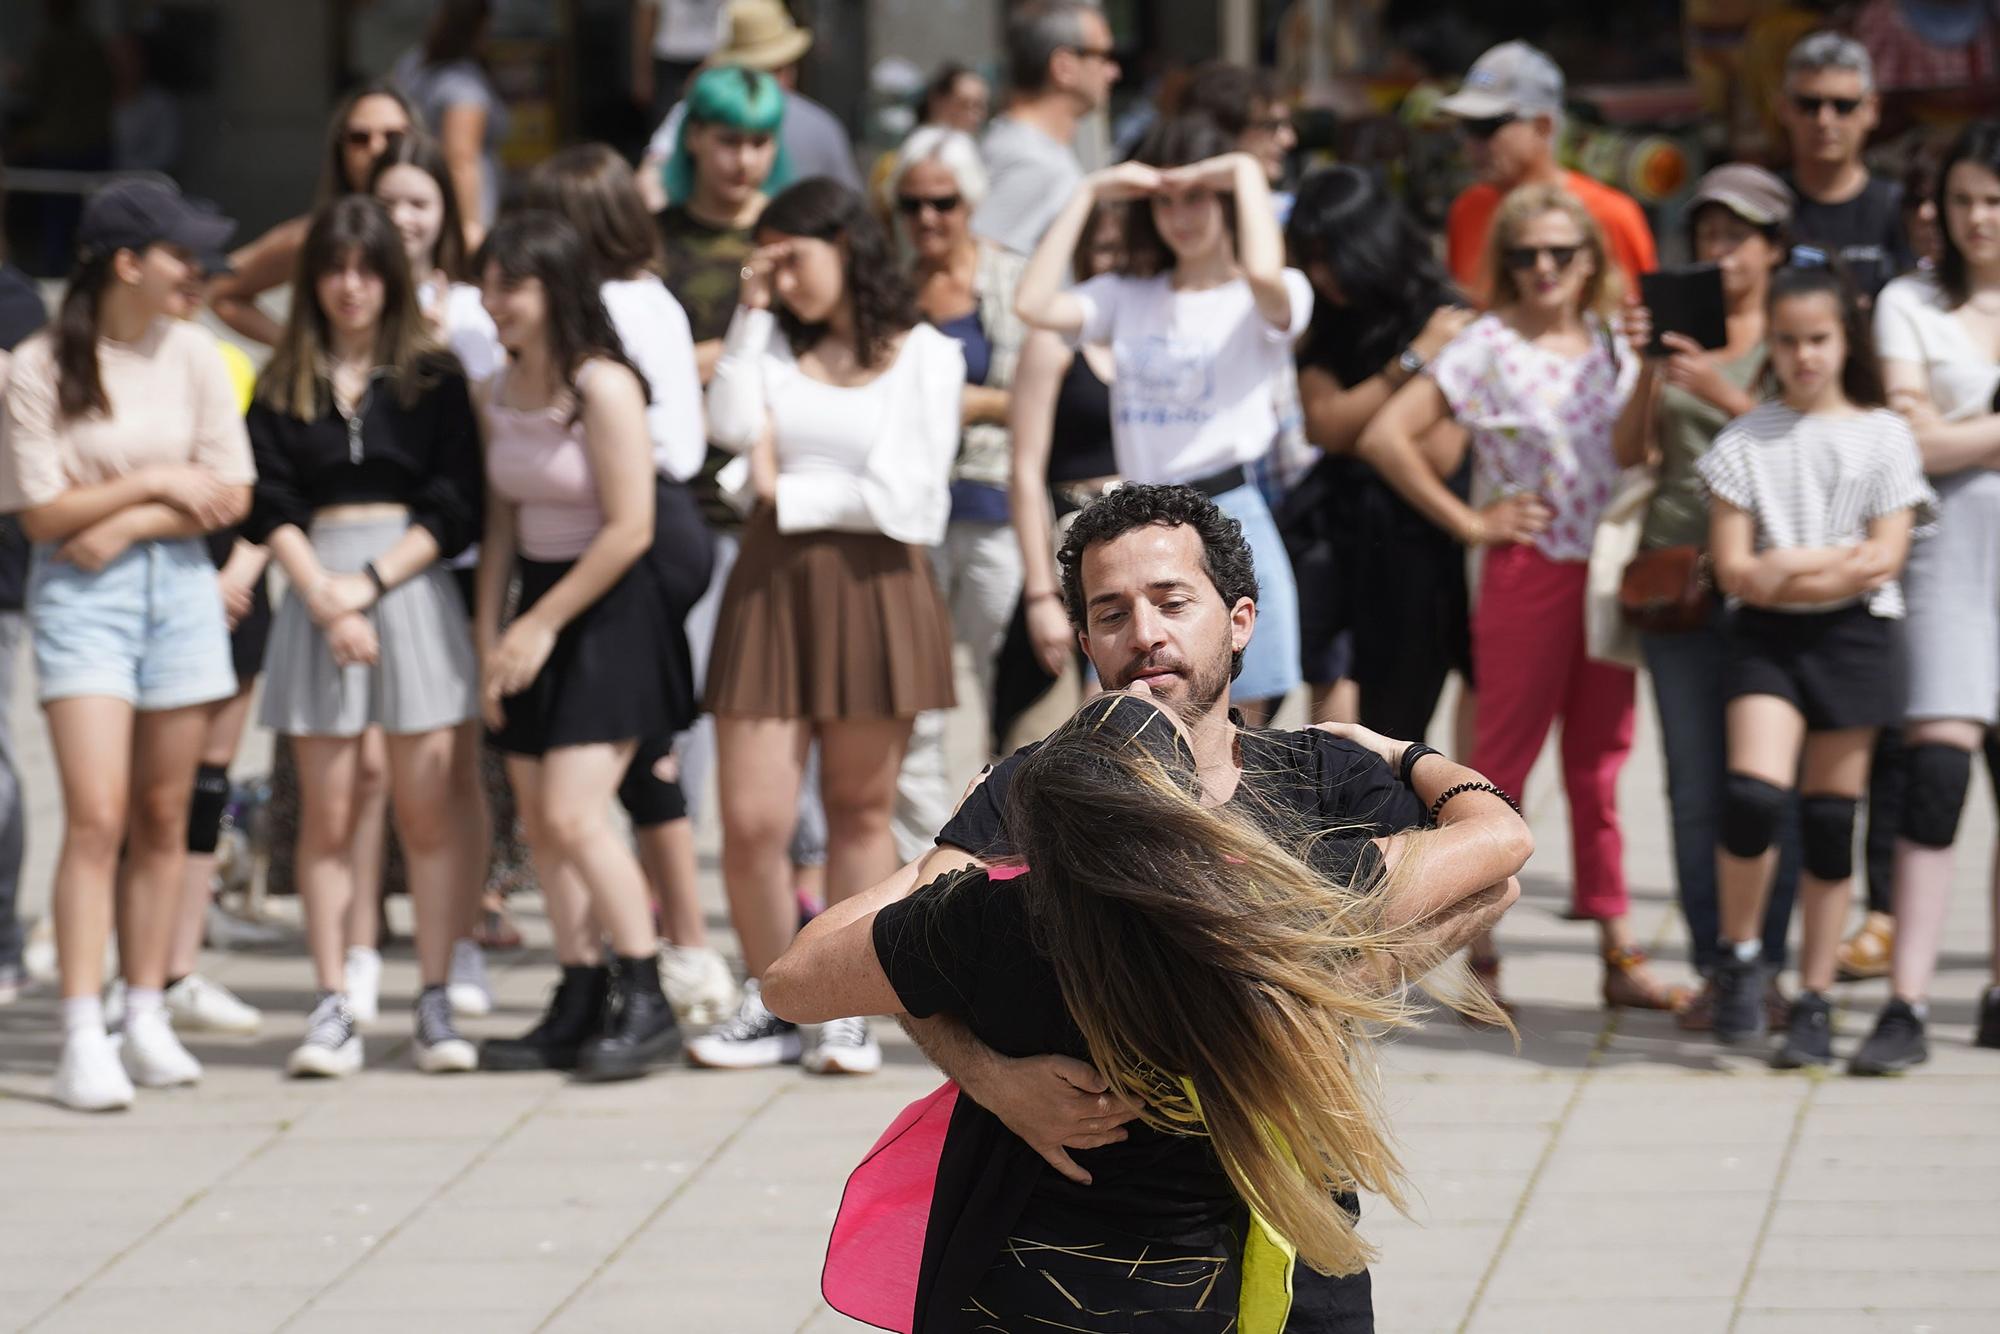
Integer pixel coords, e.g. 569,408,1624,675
882,126,1028,854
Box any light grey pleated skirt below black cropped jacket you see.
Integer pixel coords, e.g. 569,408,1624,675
262,516,480,736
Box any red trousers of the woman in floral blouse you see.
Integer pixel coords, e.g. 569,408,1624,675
1472,546,1634,920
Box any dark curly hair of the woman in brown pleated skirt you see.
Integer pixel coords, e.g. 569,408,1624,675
756,176,918,366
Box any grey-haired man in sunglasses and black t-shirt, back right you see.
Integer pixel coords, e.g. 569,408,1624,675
1778,32,1916,300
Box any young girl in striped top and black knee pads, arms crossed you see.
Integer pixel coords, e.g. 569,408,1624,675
1698,268,1936,1068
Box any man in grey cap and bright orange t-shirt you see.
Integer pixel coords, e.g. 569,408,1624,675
1438,42,1658,296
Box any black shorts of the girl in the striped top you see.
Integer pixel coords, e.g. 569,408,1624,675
1726,602,1910,732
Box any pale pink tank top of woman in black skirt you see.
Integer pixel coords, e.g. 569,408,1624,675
486,366,604,562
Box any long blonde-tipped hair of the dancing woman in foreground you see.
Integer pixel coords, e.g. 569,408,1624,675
1008,694,1506,1274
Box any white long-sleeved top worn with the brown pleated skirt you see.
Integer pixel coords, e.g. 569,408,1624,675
708,308,966,546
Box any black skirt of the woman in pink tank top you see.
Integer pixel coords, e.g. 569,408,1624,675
494,558,692,756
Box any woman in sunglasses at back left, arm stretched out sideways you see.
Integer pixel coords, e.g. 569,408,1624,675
208,82,418,346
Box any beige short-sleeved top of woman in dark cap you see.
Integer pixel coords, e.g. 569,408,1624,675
0,318,256,514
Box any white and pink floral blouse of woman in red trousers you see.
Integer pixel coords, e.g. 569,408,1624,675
1428,314,1638,560
